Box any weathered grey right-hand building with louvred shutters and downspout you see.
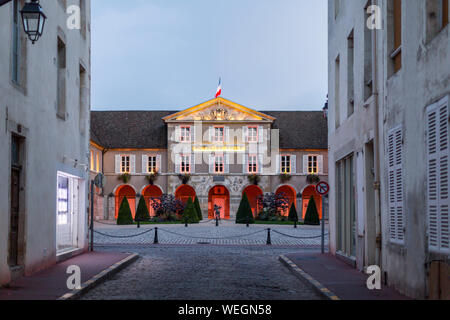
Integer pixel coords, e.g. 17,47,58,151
328,0,450,299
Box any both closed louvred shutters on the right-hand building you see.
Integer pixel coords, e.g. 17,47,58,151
387,97,450,254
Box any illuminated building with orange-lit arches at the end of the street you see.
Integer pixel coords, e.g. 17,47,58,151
91,97,328,220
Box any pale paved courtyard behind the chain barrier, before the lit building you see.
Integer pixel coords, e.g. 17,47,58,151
94,221,328,248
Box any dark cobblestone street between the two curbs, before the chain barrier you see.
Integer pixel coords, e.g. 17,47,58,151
82,245,320,300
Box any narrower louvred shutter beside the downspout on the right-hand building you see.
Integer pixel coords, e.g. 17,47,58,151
388,127,405,244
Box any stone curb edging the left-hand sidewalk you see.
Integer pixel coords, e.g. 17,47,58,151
58,253,139,300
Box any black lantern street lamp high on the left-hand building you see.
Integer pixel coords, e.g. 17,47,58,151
20,0,47,44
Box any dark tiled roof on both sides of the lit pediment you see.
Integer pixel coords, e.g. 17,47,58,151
91,111,328,149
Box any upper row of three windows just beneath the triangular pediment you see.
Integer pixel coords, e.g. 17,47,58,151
175,125,263,143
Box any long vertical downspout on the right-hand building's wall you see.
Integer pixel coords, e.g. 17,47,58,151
372,1,382,268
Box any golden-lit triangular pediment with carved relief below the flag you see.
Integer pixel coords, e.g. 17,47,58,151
163,97,276,122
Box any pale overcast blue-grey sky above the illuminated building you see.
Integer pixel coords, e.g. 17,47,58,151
92,0,327,110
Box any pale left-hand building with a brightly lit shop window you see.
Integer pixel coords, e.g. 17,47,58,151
0,0,90,285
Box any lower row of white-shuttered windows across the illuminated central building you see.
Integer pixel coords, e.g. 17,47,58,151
110,151,323,174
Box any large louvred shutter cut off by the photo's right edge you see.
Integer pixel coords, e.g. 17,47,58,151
427,97,450,254
